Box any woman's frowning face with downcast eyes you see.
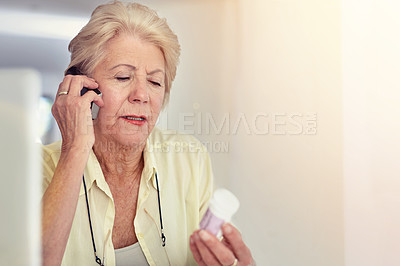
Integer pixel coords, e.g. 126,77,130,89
92,35,165,146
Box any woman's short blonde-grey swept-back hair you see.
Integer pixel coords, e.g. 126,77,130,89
68,1,180,105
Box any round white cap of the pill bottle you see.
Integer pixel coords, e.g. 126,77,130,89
209,188,240,222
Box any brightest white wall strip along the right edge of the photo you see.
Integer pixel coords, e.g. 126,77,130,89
342,0,400,266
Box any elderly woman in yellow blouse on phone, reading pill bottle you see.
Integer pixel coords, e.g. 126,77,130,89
42,2,253,265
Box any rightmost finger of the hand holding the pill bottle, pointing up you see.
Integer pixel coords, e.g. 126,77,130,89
222,223,252,263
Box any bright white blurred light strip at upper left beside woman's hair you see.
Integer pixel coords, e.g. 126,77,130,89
0,9,89,40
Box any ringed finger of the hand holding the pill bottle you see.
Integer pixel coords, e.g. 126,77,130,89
199,230,235,265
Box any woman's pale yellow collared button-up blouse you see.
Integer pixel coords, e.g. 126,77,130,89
43,128,213,266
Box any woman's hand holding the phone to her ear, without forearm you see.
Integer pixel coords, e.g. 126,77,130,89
51,75,104,151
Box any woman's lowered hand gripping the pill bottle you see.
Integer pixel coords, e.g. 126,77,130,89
190,223,255,266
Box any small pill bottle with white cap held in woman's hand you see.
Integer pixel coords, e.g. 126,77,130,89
200,188,240,236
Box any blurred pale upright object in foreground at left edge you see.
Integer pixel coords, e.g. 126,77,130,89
0,69,41,265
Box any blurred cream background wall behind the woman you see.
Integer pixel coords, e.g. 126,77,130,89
0,0,400,266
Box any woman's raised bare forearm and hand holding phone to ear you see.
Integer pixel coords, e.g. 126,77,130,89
42,75,104,266
